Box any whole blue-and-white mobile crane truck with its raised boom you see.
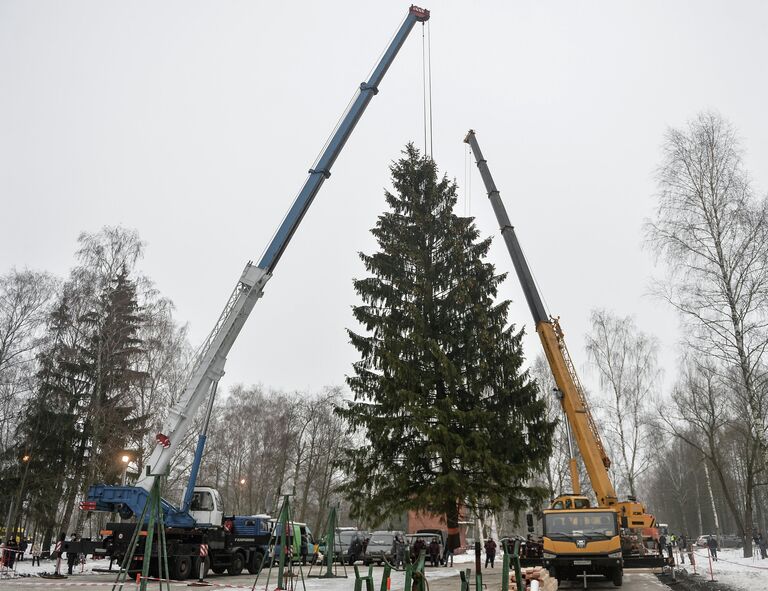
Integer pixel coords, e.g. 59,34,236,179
65,5,430,579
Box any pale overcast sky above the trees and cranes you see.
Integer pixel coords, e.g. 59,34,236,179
0,0,768,400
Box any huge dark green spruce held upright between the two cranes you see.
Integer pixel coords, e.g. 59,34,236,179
337,144,554,546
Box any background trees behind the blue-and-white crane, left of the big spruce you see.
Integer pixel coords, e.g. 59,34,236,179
0,227,346,543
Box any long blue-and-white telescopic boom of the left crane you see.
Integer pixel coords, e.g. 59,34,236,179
88,6,429,526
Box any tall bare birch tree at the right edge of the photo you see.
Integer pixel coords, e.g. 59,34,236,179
646,113,768,556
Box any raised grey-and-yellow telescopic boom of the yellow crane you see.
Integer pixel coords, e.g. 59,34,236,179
464,130,657,584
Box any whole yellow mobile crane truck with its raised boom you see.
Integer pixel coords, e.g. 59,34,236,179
464,130,664,587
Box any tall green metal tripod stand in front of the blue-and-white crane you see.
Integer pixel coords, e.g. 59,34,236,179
112,467,171,591
